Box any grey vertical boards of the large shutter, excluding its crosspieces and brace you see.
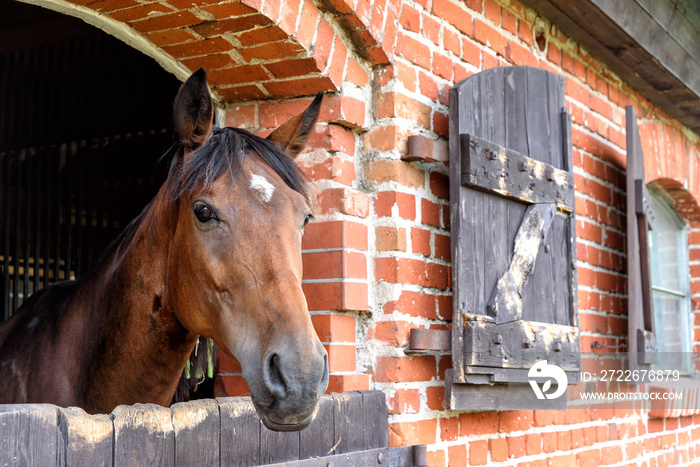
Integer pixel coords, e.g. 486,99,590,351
450,67,578,392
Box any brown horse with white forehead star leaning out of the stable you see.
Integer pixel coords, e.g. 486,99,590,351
0,70,328,430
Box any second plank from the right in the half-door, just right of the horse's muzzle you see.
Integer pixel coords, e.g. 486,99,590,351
332,391,365,454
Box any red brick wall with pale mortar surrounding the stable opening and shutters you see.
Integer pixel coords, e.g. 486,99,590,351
50,0,700,466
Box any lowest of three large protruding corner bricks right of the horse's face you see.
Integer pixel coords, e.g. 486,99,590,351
302,282,369,311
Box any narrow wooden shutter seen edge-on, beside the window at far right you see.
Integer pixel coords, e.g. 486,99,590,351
626,105,657,370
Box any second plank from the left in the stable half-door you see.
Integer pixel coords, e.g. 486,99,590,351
59,407,114,467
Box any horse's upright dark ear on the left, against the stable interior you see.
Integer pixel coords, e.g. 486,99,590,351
173,68,214,149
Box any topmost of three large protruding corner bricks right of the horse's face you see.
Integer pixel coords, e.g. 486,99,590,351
301,221,368,251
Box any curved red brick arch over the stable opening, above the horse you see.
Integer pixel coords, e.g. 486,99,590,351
23,0,382,101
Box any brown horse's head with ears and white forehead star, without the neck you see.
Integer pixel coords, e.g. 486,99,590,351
163,70,328,431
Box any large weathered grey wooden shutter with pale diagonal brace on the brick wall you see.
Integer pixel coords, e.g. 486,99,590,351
446,67,580,410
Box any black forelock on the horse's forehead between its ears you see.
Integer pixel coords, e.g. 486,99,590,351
166,127,308,202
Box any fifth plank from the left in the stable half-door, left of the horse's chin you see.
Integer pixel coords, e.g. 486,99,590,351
216,397,262,466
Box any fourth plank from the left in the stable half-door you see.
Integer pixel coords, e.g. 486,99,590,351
170,399,221,466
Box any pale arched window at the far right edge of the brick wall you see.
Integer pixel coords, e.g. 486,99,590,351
649,187,692,373
